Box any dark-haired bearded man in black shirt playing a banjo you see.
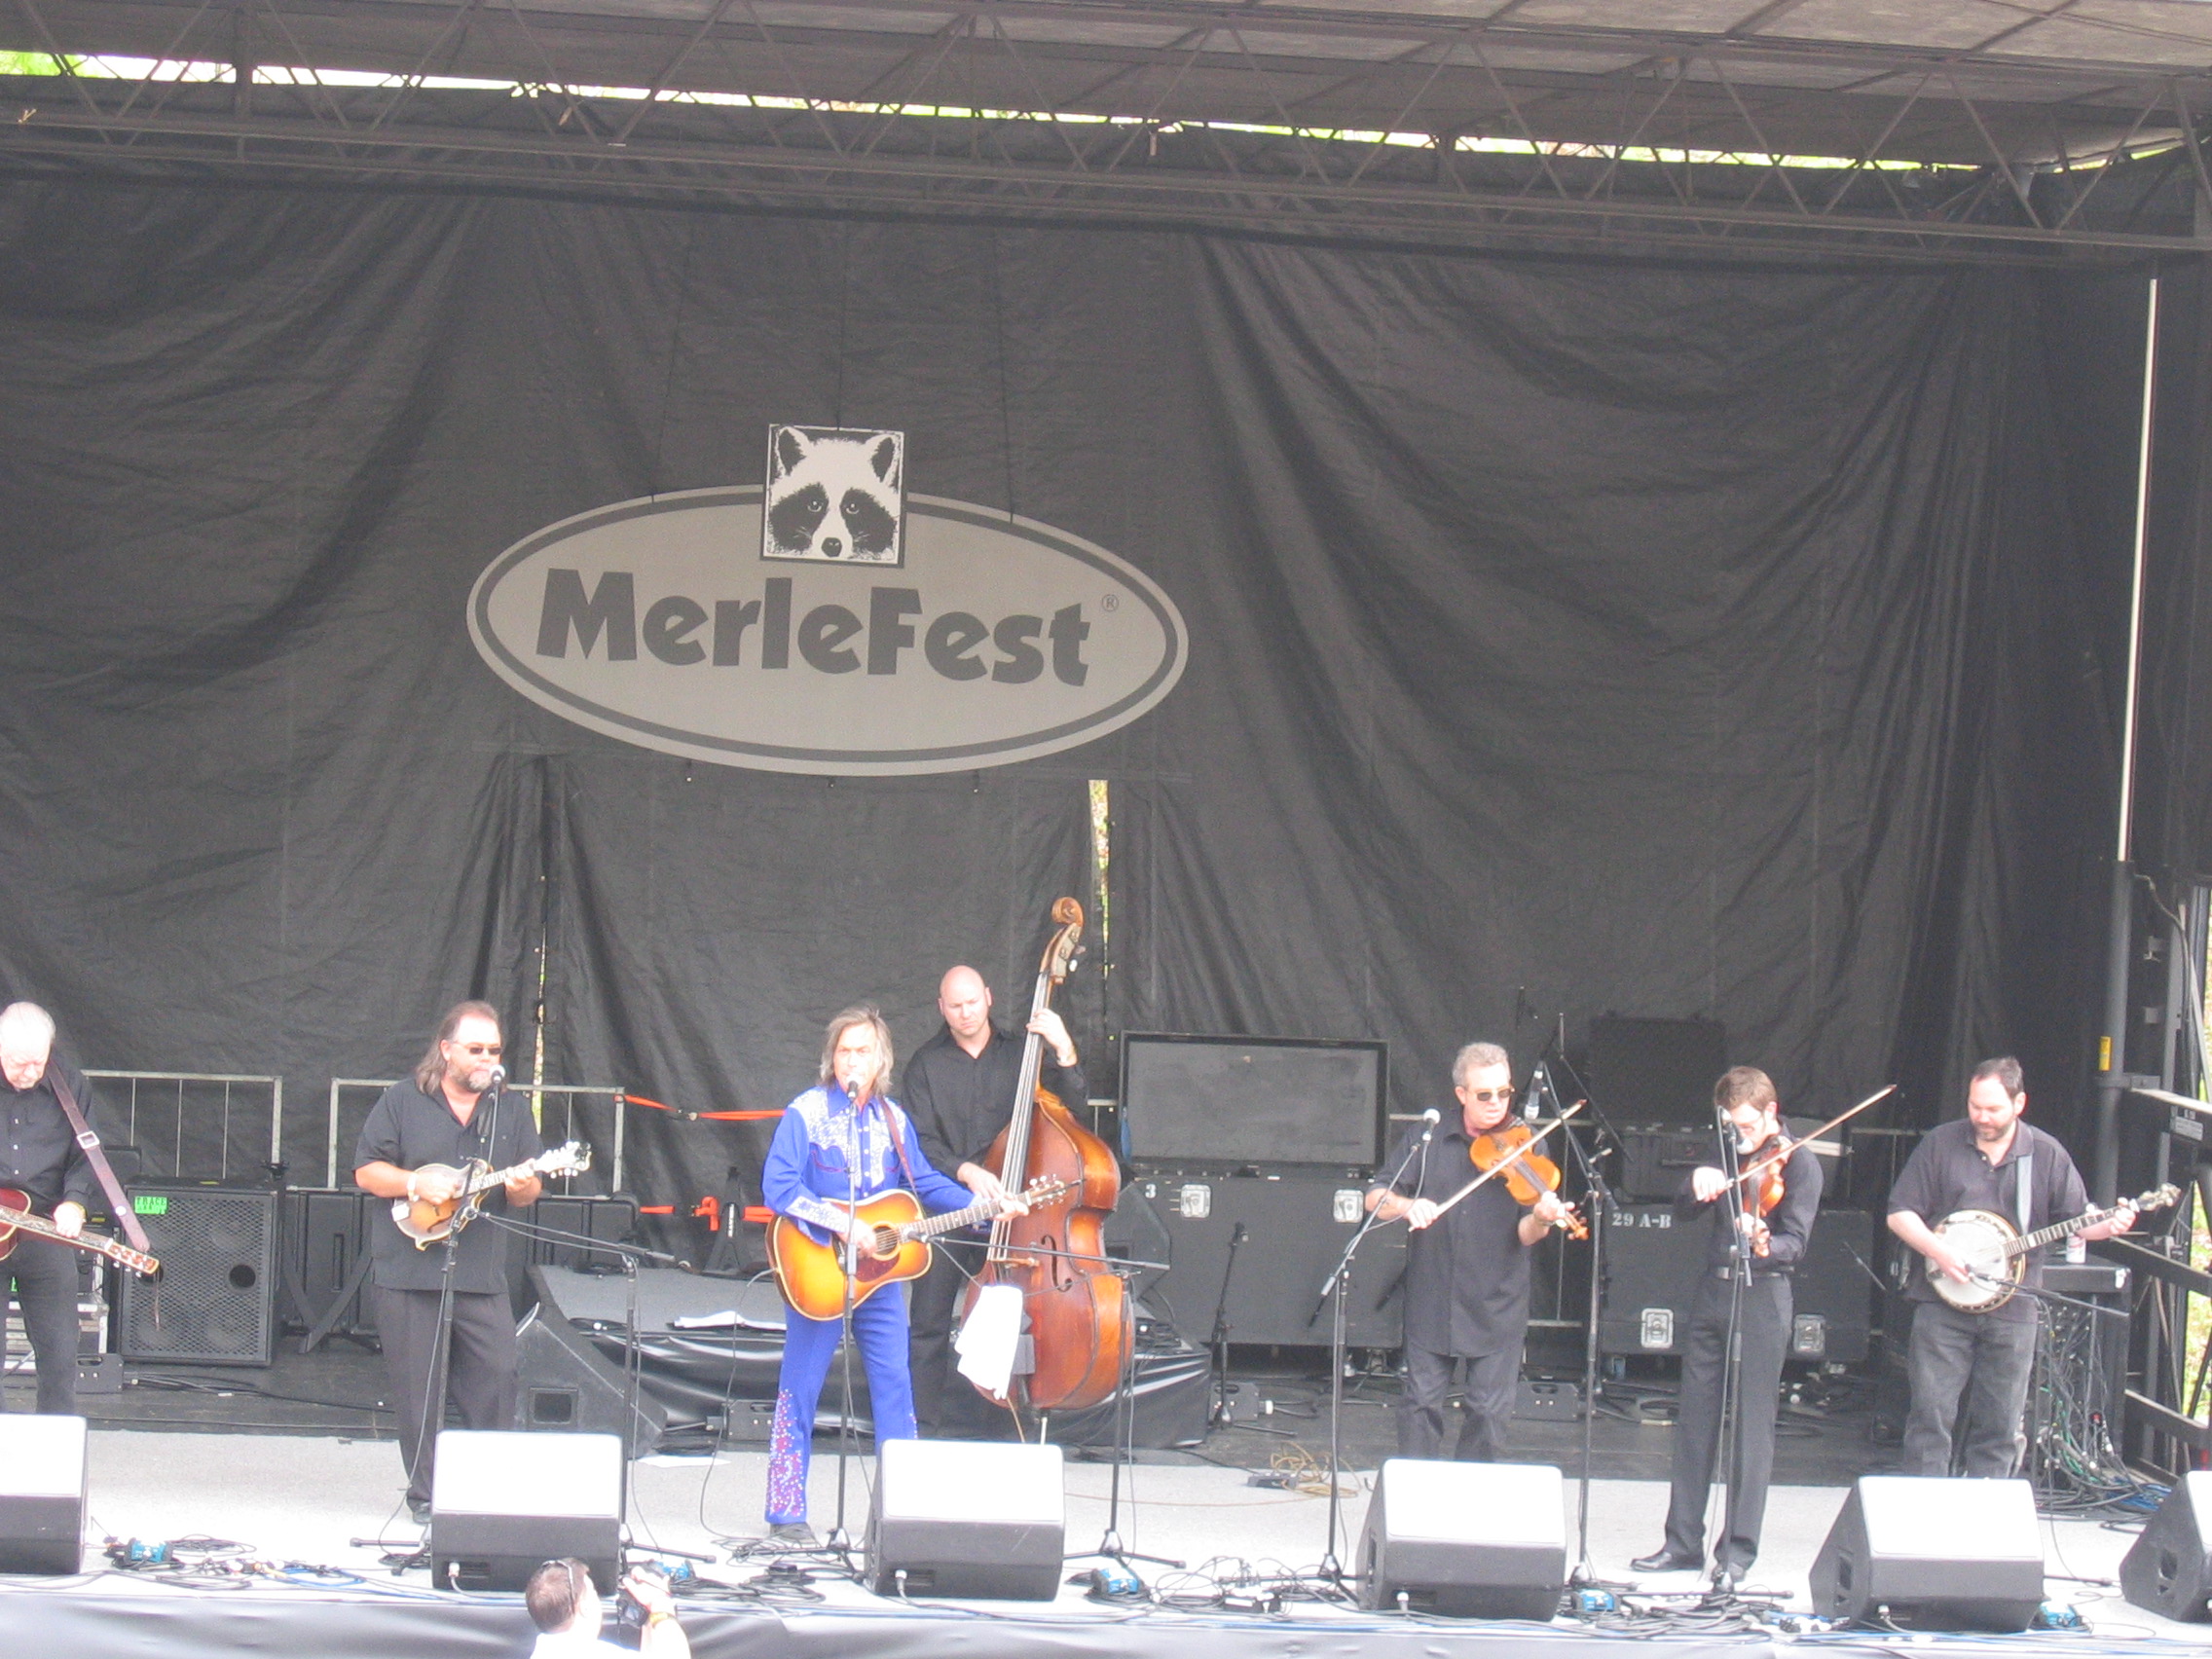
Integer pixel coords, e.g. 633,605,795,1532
1889,1055,2134,1480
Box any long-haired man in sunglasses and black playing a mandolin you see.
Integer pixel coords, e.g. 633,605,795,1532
354,1002,544,1520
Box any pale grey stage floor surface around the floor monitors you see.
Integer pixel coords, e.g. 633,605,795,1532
0,1429,2205,1659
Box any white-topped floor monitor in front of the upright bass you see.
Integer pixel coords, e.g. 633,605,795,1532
867,1440,1068,1602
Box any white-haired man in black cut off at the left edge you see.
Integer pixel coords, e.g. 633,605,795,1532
0,1002,131,1416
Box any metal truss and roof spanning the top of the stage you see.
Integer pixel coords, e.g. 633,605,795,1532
0,0,2212,261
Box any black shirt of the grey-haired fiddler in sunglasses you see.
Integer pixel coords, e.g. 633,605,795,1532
1382,1108,1529,1358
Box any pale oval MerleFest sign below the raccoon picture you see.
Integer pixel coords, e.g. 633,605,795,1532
469,487,1188,776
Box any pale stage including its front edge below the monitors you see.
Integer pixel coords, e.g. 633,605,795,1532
0,1429,2203,1659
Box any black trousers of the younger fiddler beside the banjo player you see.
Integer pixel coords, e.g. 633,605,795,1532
1666,1270,1794,1570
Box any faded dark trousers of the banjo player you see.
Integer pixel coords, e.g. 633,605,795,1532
1902,1303,2035,1480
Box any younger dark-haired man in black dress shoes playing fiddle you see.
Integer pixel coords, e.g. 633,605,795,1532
1633,1066,1821,1588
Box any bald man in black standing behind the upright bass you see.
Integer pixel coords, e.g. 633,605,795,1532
901,967,1088,1438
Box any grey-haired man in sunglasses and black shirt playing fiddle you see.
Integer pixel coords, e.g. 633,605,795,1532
1367,1042,1567,1462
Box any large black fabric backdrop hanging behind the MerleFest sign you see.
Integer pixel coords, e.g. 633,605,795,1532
0,181,2205,1201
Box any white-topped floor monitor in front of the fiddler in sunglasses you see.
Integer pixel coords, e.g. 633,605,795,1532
1358,1457,1567,1624
